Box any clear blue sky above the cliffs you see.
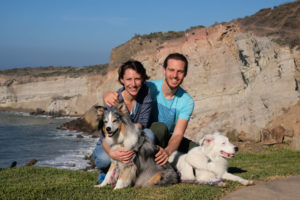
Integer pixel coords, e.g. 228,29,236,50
0,0,292,70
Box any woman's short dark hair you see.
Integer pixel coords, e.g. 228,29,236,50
118,60,150,85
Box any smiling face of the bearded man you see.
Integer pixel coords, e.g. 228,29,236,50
163,59,185,89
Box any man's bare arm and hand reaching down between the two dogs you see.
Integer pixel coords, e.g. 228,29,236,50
155,119,188,165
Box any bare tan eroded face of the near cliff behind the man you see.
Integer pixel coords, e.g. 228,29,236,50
118,23,299,141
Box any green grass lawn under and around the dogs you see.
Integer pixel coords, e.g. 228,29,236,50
0,148,300,200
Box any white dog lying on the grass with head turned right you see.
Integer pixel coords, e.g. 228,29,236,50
169,133,254,186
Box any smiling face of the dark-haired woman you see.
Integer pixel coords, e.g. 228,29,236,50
120,68,143,97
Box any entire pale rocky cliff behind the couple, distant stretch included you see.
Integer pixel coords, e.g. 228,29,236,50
0,1,300,149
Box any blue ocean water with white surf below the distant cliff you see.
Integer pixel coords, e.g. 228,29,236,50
0,112,98,170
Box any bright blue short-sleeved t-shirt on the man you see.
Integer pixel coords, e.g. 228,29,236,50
146,80,194,134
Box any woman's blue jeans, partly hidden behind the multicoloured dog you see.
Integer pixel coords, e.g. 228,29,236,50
92,128,155,170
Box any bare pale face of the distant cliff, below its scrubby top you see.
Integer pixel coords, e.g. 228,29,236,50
0,74,113,115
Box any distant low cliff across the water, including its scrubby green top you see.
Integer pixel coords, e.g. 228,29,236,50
0,65,110,115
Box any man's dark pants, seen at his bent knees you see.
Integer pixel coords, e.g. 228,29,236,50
150,122,199,153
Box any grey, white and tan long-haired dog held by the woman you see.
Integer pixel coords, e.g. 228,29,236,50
95,104,179,189
